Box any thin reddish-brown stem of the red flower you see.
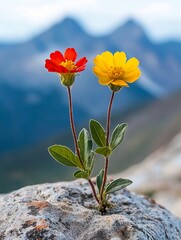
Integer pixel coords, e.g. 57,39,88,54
67,87,99,203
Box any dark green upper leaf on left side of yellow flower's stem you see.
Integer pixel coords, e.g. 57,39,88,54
89,119,106,147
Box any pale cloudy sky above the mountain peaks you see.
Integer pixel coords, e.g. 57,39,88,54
0,0,181,42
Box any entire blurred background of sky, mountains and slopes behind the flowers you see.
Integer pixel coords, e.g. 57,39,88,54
0,0,181,216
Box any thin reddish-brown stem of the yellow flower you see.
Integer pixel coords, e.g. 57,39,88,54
100,92,115,201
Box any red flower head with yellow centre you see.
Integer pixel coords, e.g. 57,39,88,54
45,48,87,75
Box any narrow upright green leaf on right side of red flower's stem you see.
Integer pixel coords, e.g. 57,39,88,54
78,128,92,164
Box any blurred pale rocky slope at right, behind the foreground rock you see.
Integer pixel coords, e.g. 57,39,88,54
114,133,181,218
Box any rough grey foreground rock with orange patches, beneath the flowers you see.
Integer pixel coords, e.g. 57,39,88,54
0,180,181,240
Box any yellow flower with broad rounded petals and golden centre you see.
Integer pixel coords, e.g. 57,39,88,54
93,51,141,91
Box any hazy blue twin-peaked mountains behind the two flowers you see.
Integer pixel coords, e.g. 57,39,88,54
0,18,181,189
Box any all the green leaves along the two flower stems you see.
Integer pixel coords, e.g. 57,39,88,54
48,119,132,198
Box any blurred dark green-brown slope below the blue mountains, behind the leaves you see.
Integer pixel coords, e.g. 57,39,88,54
0,92,181,192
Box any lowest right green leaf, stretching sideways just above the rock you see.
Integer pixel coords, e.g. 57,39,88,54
105,178,132,194
